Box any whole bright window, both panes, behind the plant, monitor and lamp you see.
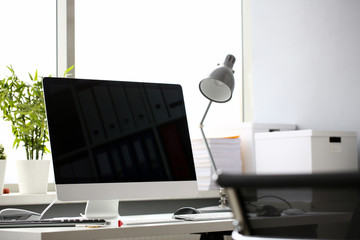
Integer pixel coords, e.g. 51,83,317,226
0,0,242,186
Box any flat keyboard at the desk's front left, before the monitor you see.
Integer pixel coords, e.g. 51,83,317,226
0,218,106,228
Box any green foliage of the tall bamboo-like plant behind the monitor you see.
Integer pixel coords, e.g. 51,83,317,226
0,65,74,160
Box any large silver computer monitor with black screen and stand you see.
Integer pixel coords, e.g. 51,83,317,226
43,77,198,218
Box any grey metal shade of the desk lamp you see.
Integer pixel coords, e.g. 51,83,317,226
199,55,235,103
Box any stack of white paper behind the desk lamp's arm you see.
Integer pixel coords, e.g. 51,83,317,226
192,136,242,190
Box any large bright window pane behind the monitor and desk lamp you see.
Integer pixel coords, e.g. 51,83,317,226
75,0,242,138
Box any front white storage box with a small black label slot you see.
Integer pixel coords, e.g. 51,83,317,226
255,130,358,174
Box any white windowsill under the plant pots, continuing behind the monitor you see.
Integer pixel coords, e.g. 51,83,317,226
0,190,219,206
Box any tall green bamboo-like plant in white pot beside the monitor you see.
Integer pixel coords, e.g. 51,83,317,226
0,66,73,193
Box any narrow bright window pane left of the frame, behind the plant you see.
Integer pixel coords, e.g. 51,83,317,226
0,0,56,183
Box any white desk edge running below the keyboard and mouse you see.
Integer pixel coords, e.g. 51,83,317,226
0,216,234,240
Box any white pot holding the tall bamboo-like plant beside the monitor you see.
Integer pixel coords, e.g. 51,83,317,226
16,160,50,194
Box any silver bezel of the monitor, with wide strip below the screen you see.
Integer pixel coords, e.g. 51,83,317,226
43,77,198,205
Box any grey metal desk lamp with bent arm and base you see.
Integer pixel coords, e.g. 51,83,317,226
199,55,235,212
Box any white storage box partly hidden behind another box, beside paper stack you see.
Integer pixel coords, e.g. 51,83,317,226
239,122,296,173
